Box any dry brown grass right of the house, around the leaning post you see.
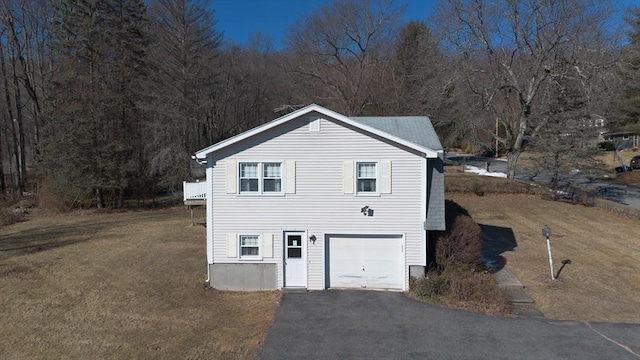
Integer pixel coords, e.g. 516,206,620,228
447,194,640,323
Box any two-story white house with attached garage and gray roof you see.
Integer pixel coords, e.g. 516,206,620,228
196,105,445,290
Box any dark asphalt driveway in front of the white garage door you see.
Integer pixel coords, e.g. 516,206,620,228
257,290,640,360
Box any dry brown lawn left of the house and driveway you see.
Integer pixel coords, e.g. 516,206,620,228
0,208,280,359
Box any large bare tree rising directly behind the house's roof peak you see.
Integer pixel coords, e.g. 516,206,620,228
285,0,402,115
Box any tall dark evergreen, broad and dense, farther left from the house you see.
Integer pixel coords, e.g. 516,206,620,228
43,0,146,207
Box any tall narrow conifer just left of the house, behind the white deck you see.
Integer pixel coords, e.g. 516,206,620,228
146,0,221,189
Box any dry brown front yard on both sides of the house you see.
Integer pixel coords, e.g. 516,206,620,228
0,189,640,359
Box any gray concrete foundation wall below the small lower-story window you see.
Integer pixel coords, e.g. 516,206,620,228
209,263,278,291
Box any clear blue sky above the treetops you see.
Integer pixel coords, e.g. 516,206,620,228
211,0,640,48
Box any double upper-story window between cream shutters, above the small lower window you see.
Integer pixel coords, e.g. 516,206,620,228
238,162,282,194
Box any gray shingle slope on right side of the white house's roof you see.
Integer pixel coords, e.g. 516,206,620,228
349,116,442,151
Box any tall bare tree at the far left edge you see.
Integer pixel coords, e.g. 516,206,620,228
0,0,56,197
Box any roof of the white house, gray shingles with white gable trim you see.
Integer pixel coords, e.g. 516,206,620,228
196,104,442,159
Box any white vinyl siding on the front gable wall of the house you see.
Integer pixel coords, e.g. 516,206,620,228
207,116,426,289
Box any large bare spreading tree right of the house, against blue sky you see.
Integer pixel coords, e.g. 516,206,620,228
434,0,615,178
